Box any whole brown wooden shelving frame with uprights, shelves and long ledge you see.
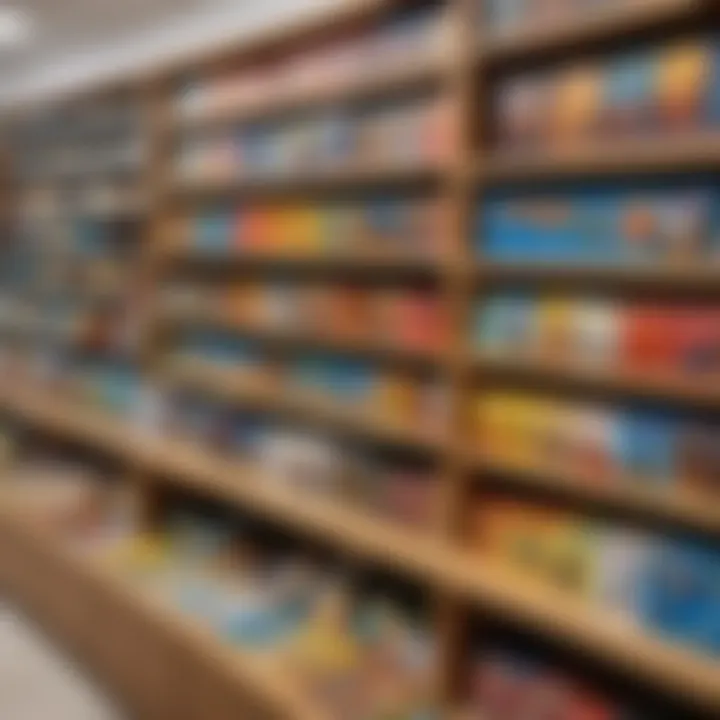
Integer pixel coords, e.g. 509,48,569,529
0,0,720,720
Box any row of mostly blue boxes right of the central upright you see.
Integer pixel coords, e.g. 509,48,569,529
475,184,720,268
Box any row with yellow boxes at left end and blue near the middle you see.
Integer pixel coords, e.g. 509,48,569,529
476,392,720,497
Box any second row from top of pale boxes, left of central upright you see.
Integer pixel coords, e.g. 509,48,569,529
175,98,455,183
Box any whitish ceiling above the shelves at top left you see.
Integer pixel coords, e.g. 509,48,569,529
0,0,337,106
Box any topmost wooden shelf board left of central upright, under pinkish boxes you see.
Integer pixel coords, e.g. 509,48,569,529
172,57,445,132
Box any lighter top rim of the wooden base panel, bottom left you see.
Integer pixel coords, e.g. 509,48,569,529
0,505,329,720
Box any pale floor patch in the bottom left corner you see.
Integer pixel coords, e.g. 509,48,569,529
0,600,124,720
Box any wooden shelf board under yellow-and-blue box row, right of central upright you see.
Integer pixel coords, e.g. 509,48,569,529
468,452,720,537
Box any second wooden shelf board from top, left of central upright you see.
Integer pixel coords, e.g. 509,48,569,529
170,161,446,199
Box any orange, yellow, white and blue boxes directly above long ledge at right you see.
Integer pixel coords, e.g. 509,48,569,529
469,498,720,656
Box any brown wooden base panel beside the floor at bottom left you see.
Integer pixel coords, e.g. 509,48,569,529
0,507,325,720
